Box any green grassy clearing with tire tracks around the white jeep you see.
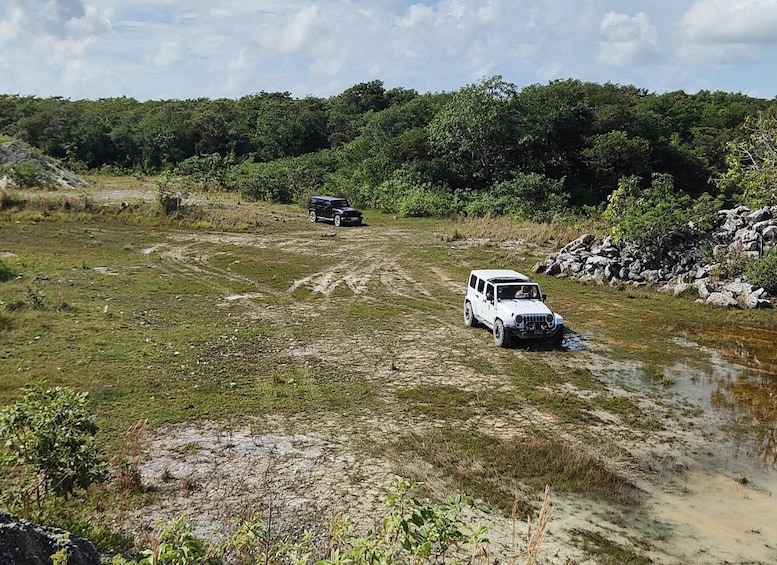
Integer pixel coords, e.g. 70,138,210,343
0,179,777,563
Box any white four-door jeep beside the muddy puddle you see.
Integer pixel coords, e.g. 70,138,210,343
464,269,564,347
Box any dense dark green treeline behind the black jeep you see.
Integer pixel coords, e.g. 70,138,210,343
0,76,771,218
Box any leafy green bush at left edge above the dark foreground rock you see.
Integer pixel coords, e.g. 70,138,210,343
0,384,106,504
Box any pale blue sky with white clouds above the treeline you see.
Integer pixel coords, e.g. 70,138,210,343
0,0,777,100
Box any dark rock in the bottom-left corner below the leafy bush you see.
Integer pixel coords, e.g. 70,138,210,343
0,512,100,565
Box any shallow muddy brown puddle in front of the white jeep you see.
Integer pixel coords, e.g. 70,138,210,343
584,336,777,563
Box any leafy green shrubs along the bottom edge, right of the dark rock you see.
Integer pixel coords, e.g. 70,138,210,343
131,478,488,565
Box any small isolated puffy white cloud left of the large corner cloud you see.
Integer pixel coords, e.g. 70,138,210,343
599,12,658,67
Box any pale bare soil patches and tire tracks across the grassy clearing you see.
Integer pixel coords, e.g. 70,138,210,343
113,213,777,564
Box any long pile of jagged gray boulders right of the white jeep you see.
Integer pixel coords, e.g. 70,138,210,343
534,206,777,308
